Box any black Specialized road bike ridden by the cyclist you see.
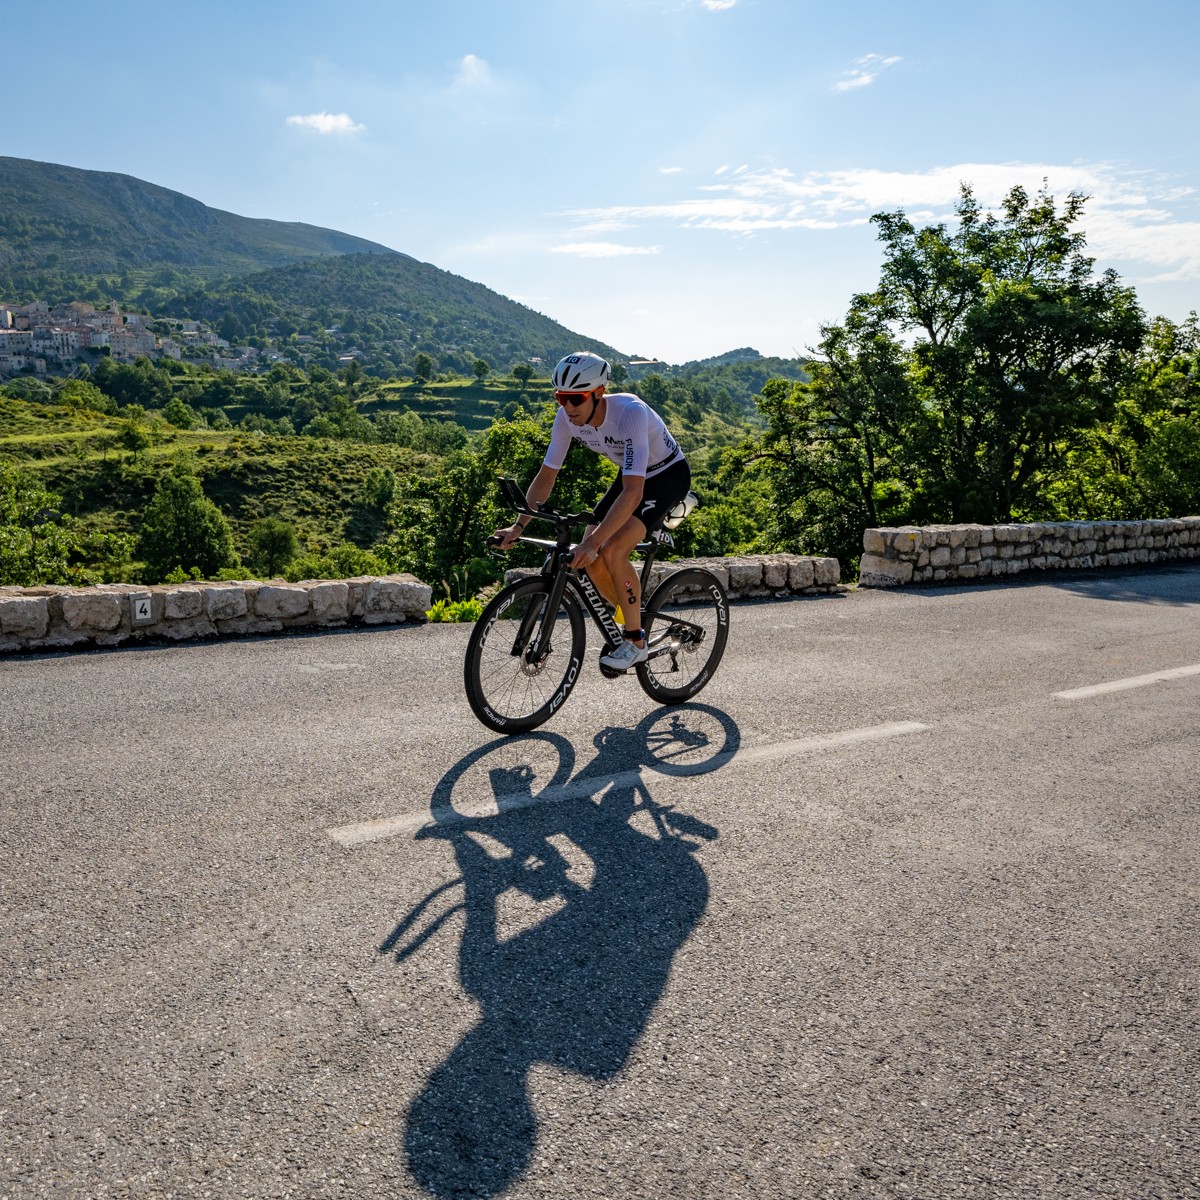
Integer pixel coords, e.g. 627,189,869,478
463,478,730,733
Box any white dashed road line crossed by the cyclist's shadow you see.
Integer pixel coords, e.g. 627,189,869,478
325,721,929,847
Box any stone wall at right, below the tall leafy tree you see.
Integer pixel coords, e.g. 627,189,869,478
858,517,1200,588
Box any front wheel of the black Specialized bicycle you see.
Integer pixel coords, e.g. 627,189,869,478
463,577,586,733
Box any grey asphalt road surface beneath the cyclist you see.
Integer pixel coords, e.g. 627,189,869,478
0,565,1200,1200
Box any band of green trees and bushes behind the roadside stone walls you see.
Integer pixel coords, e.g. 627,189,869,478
0,188,1200,590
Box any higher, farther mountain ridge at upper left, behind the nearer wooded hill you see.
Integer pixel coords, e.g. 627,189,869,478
0,157,407,277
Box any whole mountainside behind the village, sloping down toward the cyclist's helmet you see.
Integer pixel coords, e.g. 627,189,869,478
0,157,625,374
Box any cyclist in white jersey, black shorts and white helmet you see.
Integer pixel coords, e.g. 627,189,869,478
496,350,691,671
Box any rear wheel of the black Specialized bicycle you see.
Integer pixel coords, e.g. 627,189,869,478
636,566,730,704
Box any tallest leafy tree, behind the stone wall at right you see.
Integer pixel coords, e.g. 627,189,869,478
873,186,1144,523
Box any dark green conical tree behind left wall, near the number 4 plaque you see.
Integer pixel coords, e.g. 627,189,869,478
138,463,238,583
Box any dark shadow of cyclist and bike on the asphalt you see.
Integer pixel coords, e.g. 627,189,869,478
379,704,739,1198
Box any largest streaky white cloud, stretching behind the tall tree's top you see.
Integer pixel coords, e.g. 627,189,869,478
560,162,1200,281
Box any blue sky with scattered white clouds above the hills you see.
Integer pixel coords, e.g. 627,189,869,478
0,0,1200,362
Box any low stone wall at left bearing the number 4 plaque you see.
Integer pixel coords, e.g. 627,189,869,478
0,575,432,653
